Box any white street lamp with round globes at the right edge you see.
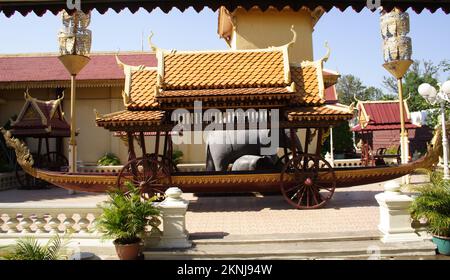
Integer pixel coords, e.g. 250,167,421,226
418,81,450,180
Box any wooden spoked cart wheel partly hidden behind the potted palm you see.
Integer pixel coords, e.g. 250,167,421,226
117,157,171,200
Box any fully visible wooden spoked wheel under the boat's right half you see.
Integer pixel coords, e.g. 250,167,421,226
280,154,336,209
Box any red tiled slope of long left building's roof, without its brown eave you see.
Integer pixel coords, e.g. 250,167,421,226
0,53,157,83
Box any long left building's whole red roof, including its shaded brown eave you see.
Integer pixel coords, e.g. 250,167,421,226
0,53,157,89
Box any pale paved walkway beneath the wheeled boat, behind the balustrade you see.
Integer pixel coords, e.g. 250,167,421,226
0,176,424,236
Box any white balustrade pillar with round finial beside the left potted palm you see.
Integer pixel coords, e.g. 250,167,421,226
157,188,192,248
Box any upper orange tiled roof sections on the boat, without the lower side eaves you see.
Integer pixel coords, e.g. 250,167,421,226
120,48,324,110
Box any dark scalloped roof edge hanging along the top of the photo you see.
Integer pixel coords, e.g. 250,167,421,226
0,0,450,17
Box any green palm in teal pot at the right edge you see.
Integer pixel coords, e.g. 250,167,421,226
410,172,450,256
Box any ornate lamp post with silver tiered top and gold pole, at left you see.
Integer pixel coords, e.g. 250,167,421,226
58,11,92,172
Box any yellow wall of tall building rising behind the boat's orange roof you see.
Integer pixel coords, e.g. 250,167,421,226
231,9,314,63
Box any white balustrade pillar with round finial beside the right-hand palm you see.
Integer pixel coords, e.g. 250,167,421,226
375,181,423,243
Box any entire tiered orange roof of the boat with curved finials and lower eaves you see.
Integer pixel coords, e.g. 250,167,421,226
96,34,353,130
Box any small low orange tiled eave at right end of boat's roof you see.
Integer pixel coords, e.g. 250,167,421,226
286,105,353,121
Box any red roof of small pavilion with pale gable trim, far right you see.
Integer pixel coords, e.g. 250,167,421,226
352,100,418,131
